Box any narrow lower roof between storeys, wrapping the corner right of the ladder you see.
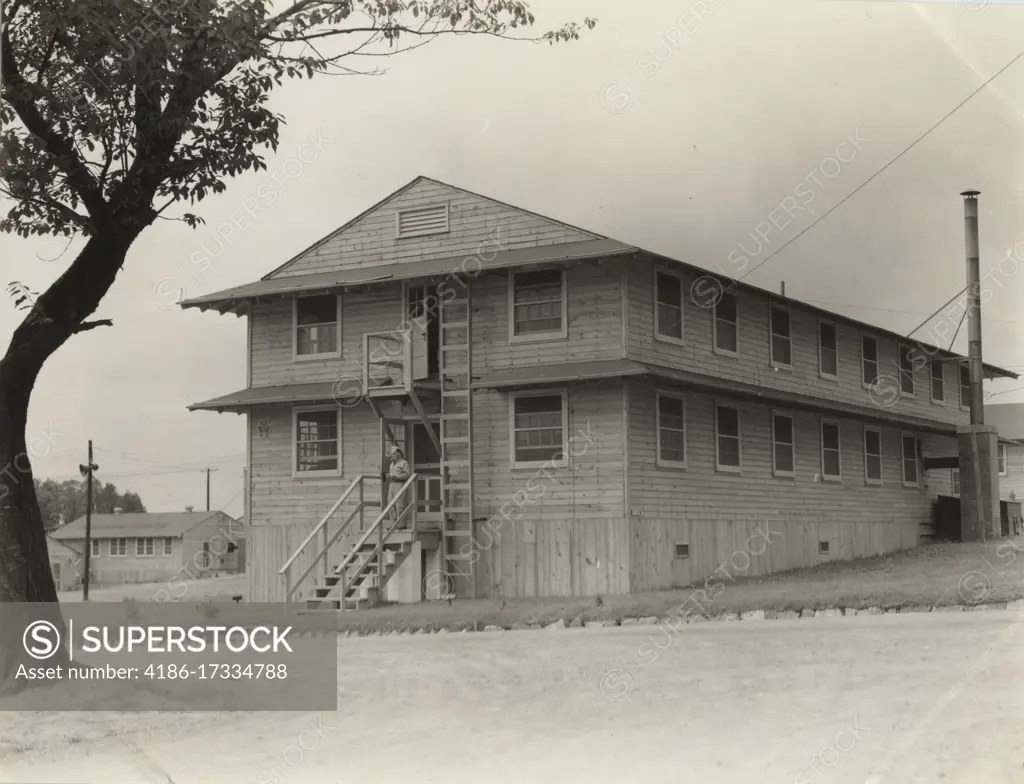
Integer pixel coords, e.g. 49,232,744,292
472,359,956,436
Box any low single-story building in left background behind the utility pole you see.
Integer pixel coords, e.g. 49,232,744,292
50,512,246,585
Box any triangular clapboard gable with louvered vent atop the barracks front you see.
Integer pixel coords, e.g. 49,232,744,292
263,176,607,280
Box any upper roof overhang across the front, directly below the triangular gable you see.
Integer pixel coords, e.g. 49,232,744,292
179,239,637,314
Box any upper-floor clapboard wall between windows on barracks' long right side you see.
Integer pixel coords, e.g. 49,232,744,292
627,257,970,425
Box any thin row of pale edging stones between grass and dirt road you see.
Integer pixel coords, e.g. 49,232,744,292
317,599,1024,638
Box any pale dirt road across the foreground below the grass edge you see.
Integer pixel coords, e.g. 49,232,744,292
0,611,1024,784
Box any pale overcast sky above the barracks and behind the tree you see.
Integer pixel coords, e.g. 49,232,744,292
0,0,1024,514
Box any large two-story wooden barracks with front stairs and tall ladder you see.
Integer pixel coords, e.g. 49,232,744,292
182,177,1016,609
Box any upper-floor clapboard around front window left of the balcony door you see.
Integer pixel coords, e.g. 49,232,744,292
250,284,403,388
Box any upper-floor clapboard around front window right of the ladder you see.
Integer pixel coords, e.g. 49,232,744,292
472,260,626,376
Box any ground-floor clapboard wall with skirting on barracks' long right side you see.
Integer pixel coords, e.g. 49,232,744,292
627,382,956,591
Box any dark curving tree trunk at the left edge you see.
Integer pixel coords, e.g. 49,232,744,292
0,225,144,693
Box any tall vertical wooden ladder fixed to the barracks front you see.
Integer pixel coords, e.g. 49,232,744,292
438,280,475,597
